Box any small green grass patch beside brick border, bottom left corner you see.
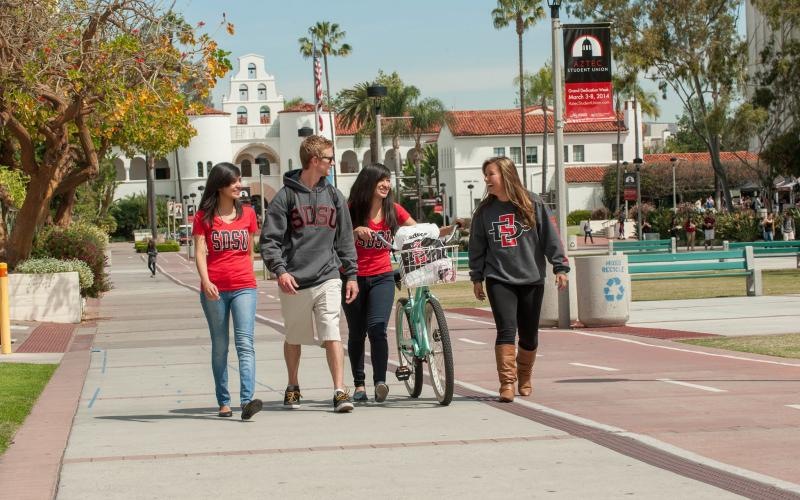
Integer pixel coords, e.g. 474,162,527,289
0,363,58,453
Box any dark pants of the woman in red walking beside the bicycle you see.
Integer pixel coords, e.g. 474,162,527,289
342,272,394,387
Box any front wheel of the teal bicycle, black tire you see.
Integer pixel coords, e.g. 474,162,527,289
425,297,455,406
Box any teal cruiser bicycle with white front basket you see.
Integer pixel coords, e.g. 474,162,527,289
381,225,459,406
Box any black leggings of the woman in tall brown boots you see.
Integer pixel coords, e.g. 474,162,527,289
486,278,544,351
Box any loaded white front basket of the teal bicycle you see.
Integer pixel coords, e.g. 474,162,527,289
395,224,458,288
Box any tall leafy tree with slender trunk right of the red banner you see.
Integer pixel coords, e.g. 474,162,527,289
569,0,747,207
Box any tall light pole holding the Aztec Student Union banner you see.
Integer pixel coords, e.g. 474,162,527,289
548,0,571,328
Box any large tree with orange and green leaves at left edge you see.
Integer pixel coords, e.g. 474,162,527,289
0,0,233,267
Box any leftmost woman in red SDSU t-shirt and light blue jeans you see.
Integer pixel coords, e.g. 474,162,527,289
192,163,262,420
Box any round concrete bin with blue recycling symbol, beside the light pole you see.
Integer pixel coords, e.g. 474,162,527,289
575,254,631,327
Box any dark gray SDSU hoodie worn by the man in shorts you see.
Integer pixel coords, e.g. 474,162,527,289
260,170,358,289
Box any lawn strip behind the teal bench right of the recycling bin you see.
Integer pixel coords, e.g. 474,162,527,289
632,269,800,301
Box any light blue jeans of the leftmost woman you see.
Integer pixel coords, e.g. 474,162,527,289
200,288,258,406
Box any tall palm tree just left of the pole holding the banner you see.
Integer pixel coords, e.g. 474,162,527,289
492,0,544,188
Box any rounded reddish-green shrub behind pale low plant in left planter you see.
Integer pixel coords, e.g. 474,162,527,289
33,223,111,297
